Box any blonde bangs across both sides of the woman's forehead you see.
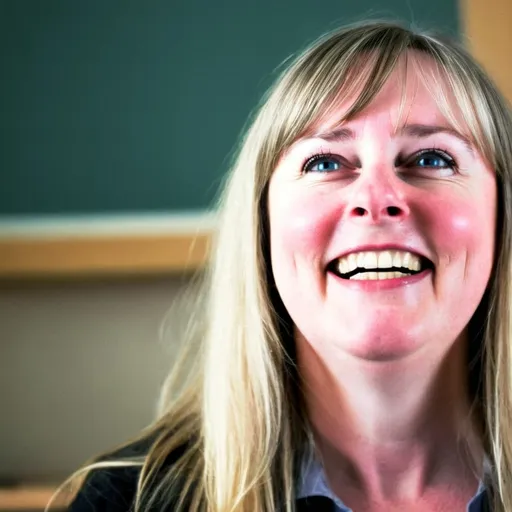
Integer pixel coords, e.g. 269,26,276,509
258,25,512,186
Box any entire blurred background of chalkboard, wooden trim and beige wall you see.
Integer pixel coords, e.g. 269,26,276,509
0,0,512,511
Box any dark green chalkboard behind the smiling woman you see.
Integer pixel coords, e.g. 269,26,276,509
0,0,459,216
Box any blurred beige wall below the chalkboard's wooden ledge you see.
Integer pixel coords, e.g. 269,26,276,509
0,278,194,479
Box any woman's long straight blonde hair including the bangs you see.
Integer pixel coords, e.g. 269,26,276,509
51,22,512,512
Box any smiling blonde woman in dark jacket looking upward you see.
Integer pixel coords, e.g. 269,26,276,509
58,23,512,512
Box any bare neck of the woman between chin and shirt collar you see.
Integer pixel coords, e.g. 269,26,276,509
297,335,482,501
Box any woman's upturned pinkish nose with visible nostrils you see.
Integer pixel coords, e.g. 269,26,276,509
345,169,409,224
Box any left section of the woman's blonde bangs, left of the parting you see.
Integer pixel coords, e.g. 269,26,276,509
258,30,410,183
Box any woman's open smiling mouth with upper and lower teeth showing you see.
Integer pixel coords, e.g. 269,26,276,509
327,251,434,280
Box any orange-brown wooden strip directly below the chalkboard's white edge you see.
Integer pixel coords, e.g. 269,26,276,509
0,234,209,278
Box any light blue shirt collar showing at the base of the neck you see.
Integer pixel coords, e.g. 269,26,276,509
297,458,487,512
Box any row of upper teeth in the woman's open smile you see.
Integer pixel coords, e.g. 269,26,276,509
338,251,421,274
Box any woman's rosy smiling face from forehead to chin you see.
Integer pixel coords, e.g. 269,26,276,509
268,58,496,360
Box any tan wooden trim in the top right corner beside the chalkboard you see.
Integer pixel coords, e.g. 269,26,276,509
459,0,512,102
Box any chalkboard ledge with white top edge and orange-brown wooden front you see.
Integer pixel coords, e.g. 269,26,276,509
0,213,215,279
